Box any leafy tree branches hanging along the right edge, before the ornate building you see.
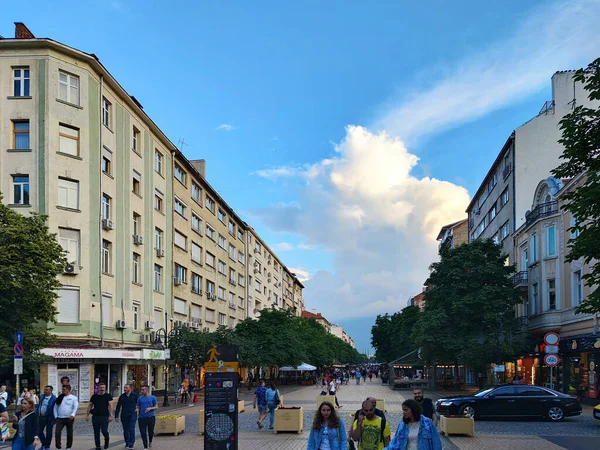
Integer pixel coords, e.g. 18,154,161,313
552,58,600,314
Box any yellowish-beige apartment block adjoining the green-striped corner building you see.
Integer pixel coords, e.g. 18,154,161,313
173,153,248,331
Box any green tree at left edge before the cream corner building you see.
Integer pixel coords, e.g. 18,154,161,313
0,199,67,367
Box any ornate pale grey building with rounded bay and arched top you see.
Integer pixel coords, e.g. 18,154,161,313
514,176,600,398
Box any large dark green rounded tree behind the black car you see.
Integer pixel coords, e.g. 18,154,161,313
415,239,524,367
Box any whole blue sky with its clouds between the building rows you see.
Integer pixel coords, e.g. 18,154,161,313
0,0,600,352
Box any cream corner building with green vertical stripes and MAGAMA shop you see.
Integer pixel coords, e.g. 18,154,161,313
0,23,176,401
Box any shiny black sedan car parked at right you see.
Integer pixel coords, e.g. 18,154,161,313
435,384,581,422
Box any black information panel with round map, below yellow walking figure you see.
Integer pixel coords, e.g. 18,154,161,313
204,372,239,450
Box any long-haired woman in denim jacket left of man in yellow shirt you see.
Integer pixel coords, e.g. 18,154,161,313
307,402,348,450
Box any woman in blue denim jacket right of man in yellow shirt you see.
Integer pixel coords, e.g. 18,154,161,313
384,399,442,450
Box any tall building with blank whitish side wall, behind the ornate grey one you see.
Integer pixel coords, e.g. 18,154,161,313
467,71,598,263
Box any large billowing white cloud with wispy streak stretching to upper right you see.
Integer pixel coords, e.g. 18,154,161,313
251,0,600,322
